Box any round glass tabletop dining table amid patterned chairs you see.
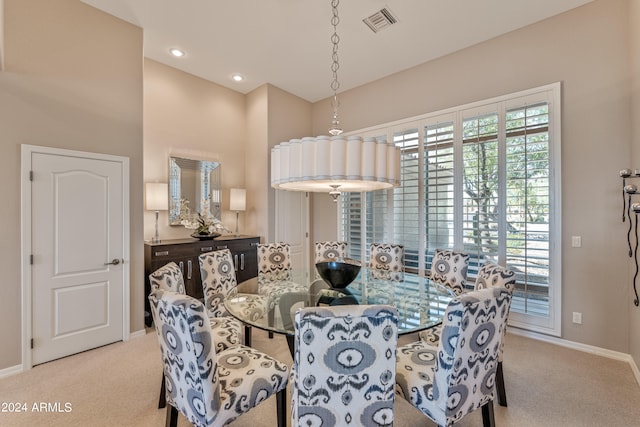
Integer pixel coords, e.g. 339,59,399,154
224,268,455,354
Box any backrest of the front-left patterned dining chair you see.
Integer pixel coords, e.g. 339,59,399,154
149,290,220,426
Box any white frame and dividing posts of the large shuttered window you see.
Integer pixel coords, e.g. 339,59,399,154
337,82,562,336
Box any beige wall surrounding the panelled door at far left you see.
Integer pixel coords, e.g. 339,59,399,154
0,0,144,369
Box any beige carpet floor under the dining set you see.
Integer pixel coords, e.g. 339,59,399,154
0,329,640,427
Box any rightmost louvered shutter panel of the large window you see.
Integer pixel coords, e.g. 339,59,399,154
506,102,551,316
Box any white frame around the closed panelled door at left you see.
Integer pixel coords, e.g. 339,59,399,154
20,144,131,371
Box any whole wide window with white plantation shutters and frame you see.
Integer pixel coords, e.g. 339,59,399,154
339,83,561,335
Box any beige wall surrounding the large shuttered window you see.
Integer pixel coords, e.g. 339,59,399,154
313,0,640,354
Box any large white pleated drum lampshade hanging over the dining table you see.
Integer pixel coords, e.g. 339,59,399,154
271,135,400,192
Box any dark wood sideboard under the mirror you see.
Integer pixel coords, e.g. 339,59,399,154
144,236,260,326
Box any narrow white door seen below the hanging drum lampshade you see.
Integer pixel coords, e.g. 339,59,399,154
275,190,309,283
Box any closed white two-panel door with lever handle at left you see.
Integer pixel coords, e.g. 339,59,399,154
31,152,128,365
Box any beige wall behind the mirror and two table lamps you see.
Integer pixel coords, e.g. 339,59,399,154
144,59,248,240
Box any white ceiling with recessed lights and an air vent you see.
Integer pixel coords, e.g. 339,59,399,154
82,0,592,102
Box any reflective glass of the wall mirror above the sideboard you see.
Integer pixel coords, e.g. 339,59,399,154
169,157,222,225
